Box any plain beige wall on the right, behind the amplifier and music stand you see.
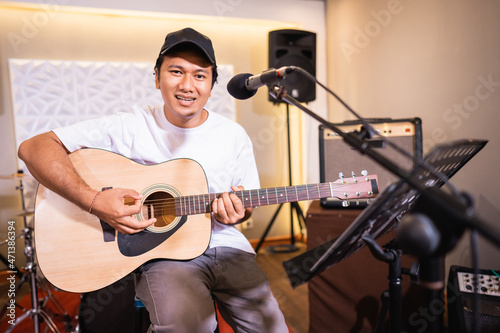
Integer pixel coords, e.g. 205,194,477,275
326,0,500,269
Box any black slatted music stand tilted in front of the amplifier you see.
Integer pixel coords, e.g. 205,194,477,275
283,140,487,332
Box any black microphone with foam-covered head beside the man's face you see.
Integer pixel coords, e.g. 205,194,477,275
227,66,295,99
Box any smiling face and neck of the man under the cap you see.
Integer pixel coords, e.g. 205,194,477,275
156,50,212,127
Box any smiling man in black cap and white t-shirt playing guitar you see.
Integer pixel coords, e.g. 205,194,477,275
19,28,288,332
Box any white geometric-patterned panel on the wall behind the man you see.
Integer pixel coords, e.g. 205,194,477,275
9,59,236,209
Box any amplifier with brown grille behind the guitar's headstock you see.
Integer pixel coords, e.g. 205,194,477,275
319,118,422,208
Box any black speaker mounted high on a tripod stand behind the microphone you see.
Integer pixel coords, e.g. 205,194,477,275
269,29,316,103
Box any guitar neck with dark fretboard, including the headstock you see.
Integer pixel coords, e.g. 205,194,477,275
175,176,378,216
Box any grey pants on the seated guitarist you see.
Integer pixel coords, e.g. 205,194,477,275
136,247,288,333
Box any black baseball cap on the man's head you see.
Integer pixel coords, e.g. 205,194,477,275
160,28,216,65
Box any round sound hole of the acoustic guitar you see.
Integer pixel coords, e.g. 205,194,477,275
142,192,176,228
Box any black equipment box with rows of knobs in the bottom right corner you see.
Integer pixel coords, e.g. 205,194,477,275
447,266,500,333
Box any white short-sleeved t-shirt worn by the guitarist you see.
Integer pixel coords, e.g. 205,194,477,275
53,105,260,253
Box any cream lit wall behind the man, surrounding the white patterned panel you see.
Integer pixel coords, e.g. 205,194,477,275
0,0,327,260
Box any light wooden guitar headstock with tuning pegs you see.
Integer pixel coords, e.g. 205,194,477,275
332,170,379,206
